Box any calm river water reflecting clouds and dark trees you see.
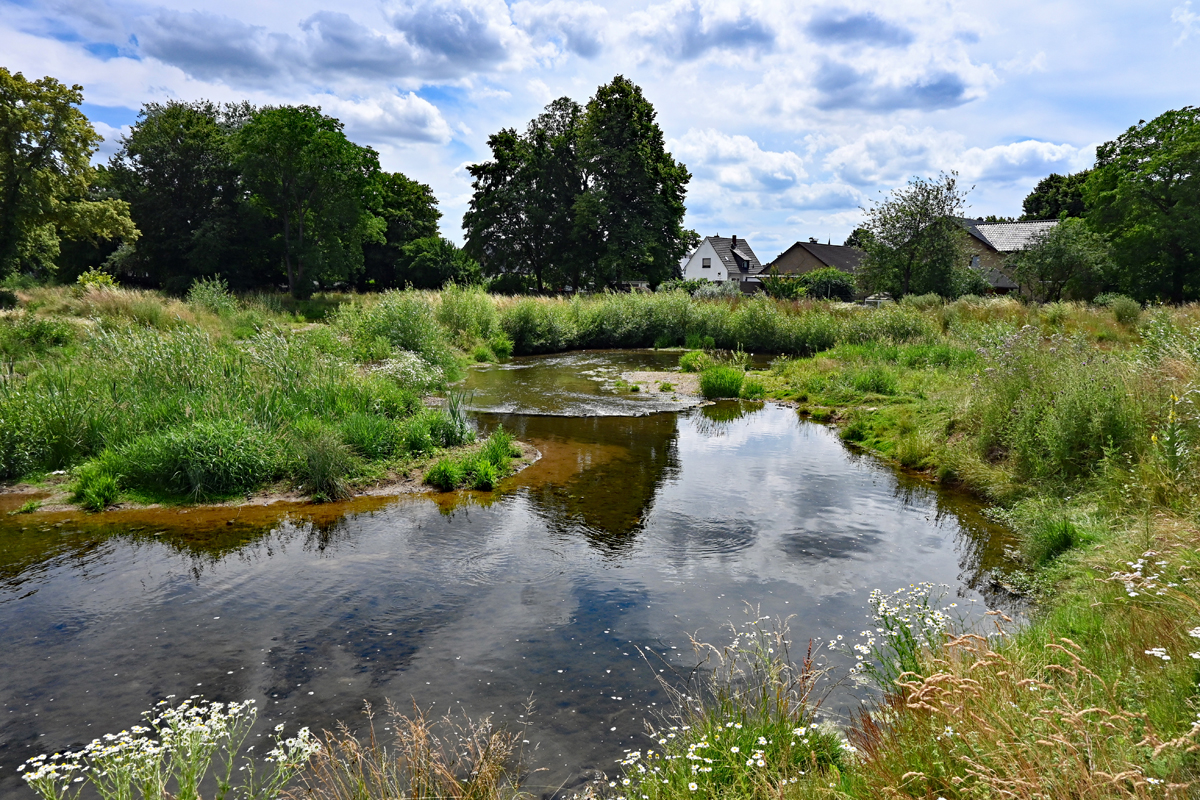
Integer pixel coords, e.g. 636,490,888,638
0,351,1007,796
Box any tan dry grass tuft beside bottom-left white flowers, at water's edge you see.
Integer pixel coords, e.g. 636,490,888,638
287,703,530,800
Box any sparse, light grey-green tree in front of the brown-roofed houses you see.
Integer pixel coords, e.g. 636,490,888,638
859,173,970,297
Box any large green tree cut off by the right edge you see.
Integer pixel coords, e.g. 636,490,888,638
1085,106,1200,303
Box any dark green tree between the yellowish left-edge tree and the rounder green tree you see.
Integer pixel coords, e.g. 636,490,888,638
109,101,269,293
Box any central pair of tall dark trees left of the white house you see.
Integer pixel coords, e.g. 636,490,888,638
463,76,696,290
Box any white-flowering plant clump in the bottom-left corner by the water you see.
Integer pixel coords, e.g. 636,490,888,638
18,697,320,800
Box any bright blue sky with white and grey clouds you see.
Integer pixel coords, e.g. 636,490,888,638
0,0,1200,261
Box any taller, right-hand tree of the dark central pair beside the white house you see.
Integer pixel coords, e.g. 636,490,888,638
575,76,691,285
